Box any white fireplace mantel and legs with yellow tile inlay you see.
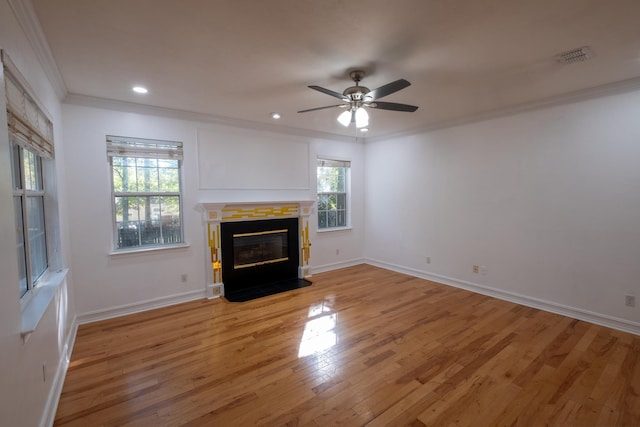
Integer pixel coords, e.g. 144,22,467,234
200,200,315,298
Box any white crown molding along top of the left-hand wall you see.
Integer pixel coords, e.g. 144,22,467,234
7,0,67,100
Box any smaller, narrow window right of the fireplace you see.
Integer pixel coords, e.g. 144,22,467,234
317,159,351,230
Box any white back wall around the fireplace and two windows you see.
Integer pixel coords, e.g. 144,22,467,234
63,104,364,319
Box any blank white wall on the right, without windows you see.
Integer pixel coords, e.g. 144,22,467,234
365,92,640,333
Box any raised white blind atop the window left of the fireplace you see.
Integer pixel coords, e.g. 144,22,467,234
107,135,183,160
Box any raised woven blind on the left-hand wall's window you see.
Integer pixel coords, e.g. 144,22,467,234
2,51,54,159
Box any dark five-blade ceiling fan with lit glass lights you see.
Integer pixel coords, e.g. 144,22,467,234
298,70,418,128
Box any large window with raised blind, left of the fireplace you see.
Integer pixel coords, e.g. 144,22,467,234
107,136,183,249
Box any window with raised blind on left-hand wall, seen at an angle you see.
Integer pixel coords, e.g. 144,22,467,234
0,50,54,300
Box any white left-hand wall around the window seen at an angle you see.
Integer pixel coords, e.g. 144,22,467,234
0,0,75,426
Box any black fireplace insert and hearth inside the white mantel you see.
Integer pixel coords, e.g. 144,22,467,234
221,218,311,301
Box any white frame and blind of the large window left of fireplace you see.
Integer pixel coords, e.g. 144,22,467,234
106,135,187,254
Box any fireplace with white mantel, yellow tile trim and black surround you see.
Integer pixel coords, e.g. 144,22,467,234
200,200,314,301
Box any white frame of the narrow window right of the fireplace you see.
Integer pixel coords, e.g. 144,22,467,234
316,156,351,233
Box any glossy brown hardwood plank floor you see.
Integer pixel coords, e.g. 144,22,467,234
55,265,640,426
